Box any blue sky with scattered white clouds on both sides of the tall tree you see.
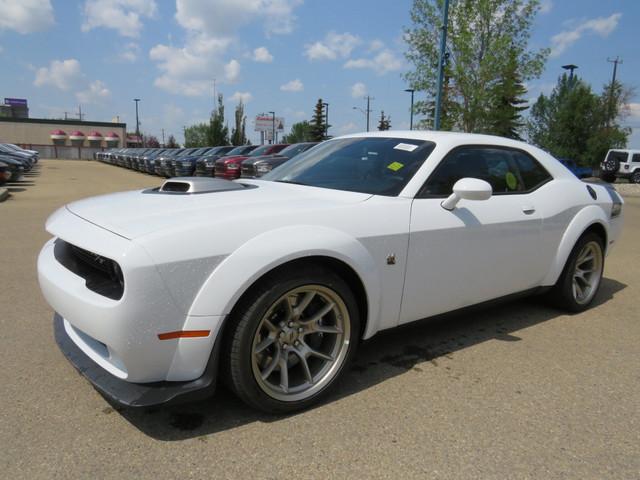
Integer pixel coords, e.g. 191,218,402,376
0,0,640,148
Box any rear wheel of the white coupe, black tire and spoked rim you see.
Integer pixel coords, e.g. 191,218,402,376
549,233,604,312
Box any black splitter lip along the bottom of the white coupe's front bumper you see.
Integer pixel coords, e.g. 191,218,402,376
53,313,221,407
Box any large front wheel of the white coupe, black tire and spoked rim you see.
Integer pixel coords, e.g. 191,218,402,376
226,265,360,413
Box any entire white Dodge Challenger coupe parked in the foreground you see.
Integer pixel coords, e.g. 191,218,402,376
38,131,624,413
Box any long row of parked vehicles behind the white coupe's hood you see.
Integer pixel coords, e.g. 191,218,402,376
94,142,317,180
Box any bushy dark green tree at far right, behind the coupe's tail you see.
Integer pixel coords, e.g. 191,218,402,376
527,73,633,168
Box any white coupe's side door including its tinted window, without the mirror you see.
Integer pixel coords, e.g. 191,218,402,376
400,146,551,323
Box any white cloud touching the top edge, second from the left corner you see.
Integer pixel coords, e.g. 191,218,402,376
82,0,158,37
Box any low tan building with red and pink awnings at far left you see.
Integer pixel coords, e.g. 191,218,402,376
0,98,134,159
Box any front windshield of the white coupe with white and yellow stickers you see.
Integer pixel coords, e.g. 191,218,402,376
262,137,435,196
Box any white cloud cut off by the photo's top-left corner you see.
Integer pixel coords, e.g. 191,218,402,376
0,0,56,34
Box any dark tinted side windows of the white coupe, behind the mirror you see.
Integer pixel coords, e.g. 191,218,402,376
419,147,551,197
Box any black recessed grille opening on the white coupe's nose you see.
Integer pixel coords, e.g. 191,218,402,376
54,239,124,300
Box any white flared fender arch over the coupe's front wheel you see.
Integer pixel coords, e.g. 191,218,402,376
189,225,382,338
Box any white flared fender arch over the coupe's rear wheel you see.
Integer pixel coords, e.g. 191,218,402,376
542,205,609,285
